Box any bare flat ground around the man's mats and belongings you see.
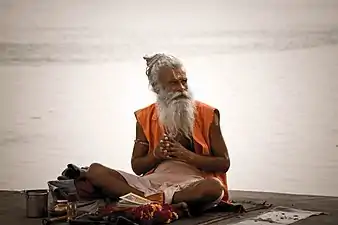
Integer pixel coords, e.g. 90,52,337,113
0,191,338,225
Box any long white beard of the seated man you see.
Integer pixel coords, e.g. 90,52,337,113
157,90,195,139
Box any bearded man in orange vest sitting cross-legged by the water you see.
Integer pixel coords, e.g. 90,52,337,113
85,54,230,213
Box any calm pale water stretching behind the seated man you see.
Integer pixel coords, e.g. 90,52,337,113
0,0,338,196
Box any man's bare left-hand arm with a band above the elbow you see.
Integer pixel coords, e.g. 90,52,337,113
131,122,158,175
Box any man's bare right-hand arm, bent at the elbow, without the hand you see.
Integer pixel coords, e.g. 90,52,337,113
191,110,230,173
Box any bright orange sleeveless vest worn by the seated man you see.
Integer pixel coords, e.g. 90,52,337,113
135,101,229,201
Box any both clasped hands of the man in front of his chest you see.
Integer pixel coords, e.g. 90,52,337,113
153,135,195,163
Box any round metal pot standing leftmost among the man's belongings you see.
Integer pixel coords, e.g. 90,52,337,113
24,189,48,218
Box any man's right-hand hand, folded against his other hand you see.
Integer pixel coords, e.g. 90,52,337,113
168,140,196,163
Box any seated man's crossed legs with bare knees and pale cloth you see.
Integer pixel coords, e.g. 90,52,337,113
84,163,224,214
